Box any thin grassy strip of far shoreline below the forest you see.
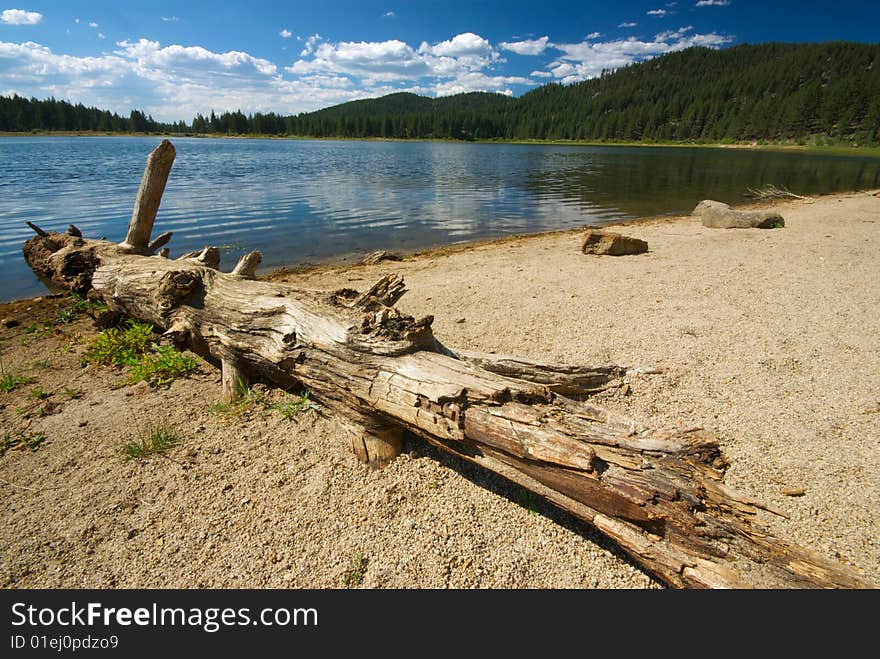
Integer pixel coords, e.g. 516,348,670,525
0,131,880,158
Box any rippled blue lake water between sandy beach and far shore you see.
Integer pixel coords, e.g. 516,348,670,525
0,137,880,301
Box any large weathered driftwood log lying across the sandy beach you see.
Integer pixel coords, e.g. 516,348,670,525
23,143,867,588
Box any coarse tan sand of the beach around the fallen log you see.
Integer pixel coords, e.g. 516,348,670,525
0,192,880,588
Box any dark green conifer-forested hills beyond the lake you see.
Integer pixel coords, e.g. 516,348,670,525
0,42,880,145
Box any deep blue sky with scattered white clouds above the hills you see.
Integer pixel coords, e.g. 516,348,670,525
0,0,880,121
